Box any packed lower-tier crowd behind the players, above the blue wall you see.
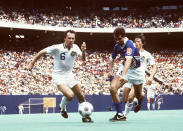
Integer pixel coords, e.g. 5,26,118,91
0,49,183,95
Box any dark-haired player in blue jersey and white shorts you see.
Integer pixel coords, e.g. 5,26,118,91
108,28,144,122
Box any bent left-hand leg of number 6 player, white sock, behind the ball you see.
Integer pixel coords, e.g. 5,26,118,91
57,84,74,118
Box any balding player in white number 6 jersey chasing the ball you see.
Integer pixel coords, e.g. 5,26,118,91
28,30,93,122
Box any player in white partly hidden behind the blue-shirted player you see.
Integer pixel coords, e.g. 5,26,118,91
123,35,156,116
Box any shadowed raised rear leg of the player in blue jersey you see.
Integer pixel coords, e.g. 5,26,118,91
133,84,144,112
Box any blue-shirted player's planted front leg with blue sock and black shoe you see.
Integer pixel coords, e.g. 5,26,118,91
109,76,126,122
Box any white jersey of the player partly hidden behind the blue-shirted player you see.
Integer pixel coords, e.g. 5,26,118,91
140,50,155,73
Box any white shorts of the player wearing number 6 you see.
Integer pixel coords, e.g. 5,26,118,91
52,73,79,88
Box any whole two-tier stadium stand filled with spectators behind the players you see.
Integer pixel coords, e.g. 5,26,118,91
0,0,183,95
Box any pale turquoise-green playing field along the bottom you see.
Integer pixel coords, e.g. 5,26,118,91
0,110,183,131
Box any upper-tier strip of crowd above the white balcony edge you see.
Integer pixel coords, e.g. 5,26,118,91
0,7,183,28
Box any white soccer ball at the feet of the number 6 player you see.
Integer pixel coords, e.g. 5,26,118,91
78,102,93,117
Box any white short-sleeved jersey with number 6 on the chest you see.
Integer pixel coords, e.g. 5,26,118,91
45,43,82,74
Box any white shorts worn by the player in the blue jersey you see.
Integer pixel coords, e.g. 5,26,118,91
117,65,145,88
